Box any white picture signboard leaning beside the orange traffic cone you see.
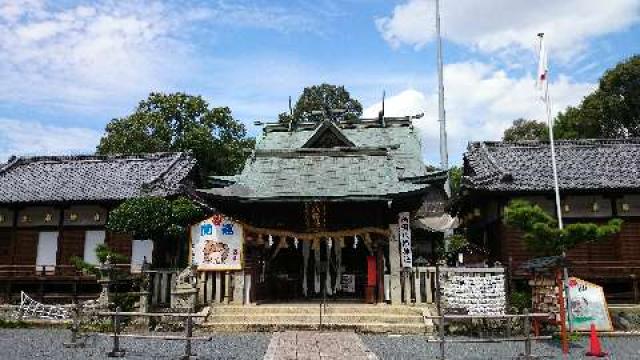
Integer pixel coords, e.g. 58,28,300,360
567,277,613,331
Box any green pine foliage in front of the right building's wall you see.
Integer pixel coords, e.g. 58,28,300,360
503,200,622,255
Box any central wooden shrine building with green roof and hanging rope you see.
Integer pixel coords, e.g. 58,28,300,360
199,117,446,302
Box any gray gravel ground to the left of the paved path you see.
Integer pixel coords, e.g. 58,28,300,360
0,329,271,360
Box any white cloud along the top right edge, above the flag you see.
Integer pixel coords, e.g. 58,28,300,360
376,0,640,57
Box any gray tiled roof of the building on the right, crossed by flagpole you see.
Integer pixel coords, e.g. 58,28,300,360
463,139,640,192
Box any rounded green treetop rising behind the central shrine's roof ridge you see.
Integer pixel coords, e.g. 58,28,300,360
278,84,362,124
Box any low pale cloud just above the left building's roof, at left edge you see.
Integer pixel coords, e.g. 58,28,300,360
0,118,101,163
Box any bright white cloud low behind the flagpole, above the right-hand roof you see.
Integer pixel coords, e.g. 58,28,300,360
364,62,596,164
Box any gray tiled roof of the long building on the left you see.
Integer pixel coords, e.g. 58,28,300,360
0,153,195,203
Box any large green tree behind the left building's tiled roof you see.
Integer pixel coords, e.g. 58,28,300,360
97,93,254,180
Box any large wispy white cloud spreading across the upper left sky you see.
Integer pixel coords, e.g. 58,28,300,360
0,0,314,115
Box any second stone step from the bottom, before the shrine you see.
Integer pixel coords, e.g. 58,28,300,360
206,313,424,324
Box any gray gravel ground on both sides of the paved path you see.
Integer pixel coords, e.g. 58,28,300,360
0,329,640,360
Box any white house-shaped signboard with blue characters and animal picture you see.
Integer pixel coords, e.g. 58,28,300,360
191,214,244,271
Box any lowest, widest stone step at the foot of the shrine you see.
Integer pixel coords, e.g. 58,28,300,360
200,321,433,334
